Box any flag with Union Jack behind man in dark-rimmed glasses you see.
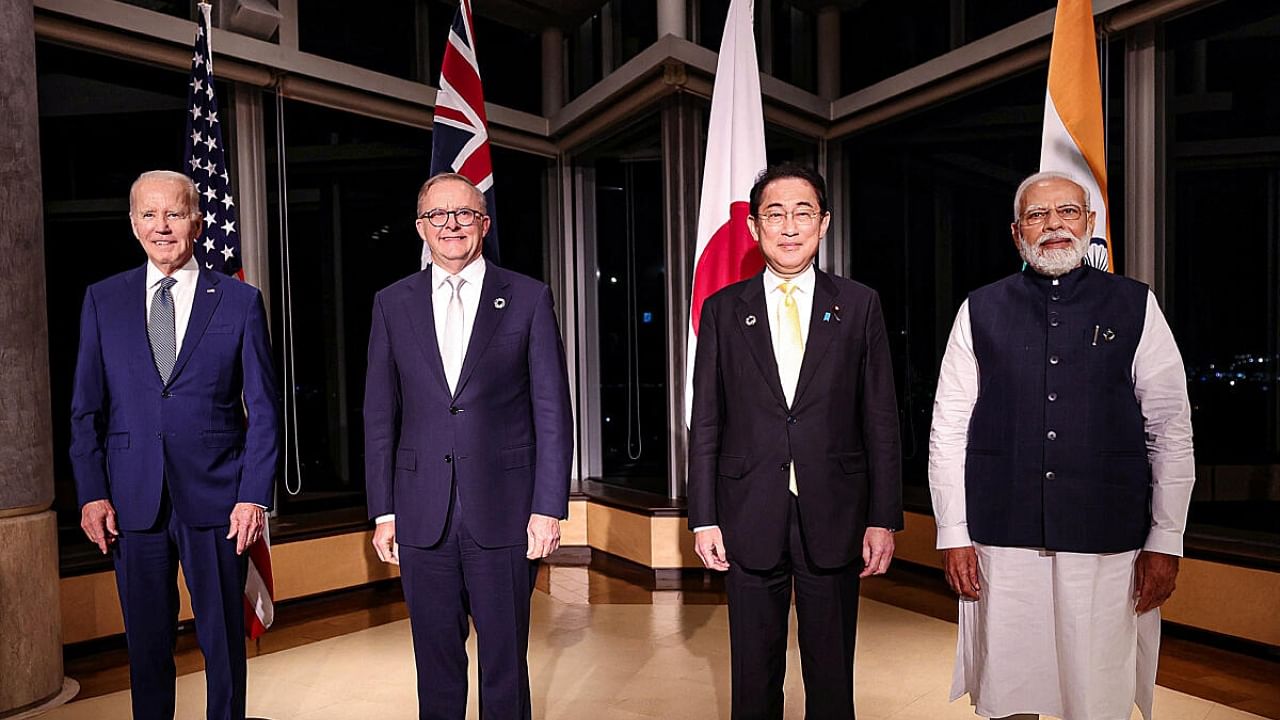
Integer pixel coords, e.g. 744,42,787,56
422,0,498,265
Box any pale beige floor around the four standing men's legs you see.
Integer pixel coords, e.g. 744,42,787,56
45,579,1260,720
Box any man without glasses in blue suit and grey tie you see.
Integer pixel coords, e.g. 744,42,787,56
72,170,279,720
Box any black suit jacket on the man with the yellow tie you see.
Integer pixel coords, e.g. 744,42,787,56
689,270,902,570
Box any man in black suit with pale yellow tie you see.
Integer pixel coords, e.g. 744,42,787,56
689,165,902,720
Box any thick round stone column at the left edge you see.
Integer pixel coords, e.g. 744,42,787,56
0,0,63,716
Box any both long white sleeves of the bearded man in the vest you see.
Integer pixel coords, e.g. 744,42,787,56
929,283,1196,556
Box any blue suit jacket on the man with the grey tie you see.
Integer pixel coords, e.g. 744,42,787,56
72,265,279,530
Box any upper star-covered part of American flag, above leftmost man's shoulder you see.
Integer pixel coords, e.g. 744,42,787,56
183,3,244,279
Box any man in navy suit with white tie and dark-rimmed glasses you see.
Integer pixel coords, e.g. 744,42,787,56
365,173,573,720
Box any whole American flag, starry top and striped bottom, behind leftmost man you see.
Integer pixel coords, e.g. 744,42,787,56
183,3,275,639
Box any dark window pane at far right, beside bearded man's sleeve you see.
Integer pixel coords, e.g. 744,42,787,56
1164,3,1280,542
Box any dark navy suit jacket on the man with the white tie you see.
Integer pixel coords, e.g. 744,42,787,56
365,263,573,547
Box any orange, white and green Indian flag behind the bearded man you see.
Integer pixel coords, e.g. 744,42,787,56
1041,0,1115,272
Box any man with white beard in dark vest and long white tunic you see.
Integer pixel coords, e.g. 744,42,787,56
929,173,1196,720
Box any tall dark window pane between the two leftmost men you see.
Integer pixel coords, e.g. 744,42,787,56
264,101,431,514
